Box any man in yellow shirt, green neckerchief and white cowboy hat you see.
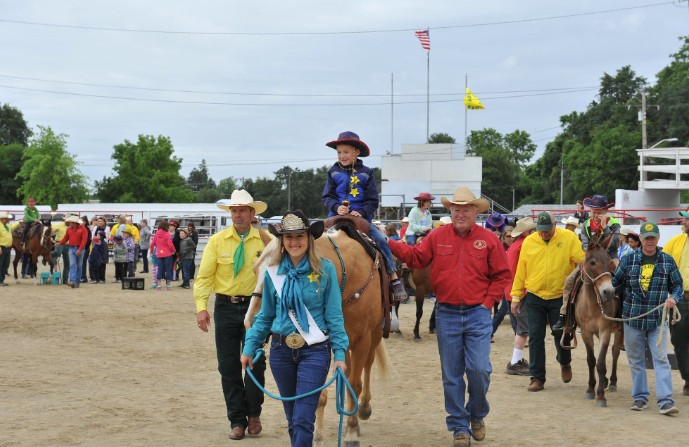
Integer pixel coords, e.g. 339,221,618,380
194,190,268,440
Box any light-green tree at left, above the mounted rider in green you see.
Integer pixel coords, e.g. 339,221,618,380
17,126,88,209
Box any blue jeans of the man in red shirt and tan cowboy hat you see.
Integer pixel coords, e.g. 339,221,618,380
435,303,493,436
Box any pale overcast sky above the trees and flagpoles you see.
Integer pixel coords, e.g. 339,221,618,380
0,0,689,189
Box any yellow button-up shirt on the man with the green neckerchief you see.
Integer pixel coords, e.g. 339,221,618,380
194,226,265,313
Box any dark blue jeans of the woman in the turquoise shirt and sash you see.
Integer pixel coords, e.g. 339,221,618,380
270,340,330,446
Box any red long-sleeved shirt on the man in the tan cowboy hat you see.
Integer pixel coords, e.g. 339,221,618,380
389,225,512,308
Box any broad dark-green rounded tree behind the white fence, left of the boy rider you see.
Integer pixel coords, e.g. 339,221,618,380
96,135,194,203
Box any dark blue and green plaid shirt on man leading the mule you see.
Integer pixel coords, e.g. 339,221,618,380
612,248,684,330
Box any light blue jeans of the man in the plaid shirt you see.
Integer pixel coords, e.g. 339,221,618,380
624,323,675,407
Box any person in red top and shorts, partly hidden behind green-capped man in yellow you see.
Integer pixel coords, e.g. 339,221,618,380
505,217,536,376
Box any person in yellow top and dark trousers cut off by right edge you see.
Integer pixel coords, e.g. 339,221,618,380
663,210,689,396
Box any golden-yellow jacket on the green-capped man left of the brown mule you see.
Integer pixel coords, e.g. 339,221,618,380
510,228,584,300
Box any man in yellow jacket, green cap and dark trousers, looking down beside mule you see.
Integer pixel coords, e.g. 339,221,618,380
510,212,584,391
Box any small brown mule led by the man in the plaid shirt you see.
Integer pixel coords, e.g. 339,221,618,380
563,236,622,407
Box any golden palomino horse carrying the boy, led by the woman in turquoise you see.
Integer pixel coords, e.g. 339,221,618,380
244,229,388,446
